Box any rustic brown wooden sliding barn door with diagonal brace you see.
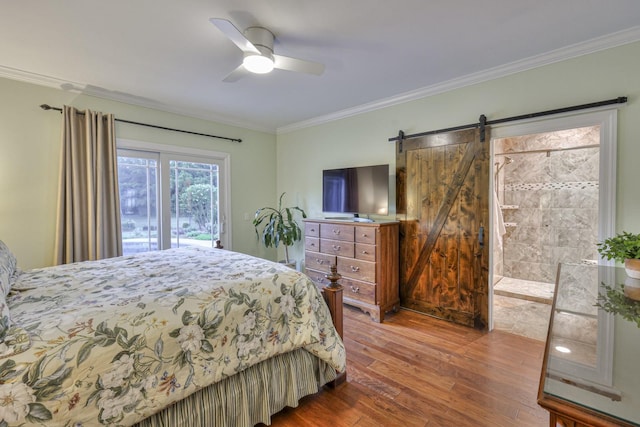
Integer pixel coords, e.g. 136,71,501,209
396,129,490,329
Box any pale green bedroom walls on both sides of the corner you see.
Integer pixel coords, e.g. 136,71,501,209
5,43,640,268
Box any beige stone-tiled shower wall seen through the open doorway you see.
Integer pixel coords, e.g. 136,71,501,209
494,126,600,283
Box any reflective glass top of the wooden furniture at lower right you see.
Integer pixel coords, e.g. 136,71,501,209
542,264,640,426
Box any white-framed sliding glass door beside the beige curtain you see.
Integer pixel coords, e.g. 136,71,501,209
118,145,226,255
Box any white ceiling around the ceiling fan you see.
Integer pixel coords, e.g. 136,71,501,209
0,0,640,132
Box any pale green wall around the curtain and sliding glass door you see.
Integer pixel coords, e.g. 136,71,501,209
0,78,276,269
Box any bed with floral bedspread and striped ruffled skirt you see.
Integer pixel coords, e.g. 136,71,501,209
0,242,346,427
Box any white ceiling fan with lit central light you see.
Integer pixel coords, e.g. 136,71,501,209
209,18,324,82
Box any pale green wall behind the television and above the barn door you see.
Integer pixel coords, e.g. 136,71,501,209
278,43,640,266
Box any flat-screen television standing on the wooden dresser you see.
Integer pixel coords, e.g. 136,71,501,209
322,165,389,217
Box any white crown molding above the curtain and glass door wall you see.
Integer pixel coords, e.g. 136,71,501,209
0,65,275,134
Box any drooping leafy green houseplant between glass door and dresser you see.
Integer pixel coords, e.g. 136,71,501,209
253,193,307,265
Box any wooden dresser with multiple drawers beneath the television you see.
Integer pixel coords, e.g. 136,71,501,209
304,219,400,322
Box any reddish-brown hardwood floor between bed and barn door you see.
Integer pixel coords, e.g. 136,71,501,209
272,306,549,427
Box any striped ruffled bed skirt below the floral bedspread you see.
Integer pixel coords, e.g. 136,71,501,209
136,349,336,427
